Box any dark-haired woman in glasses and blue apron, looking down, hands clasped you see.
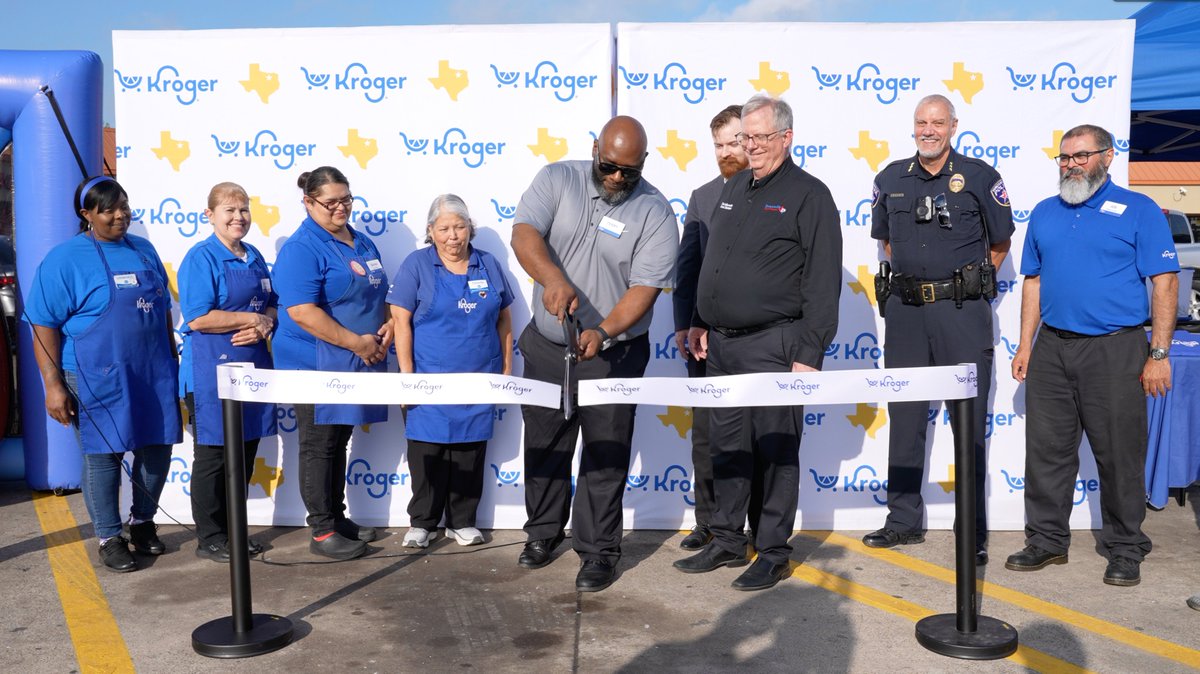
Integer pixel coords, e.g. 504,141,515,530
271,167,392,559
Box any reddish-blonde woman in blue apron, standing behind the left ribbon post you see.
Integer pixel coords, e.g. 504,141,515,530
179,182,278,562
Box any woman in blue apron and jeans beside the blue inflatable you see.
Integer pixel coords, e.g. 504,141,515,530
25,176,182,572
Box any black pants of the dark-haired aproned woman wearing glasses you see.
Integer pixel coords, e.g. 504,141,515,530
292,404,354,536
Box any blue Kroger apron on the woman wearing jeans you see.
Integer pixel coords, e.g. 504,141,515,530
74,236,182,453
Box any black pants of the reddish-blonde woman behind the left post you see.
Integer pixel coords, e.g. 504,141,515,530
186,393,258,546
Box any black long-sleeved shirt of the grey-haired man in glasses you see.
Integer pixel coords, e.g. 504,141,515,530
696,158,841,366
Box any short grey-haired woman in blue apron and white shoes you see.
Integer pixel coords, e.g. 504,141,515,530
388,194,512,548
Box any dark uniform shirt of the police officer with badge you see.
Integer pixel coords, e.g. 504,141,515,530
871,150,1015,281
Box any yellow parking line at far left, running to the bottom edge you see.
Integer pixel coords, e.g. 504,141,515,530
34,493,133,673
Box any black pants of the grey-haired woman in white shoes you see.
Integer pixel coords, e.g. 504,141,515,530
408,440,487,529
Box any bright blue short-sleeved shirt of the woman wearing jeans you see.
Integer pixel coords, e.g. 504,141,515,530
25,234,170,371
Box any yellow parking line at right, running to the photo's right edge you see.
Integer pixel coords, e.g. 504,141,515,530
798,531,1200,668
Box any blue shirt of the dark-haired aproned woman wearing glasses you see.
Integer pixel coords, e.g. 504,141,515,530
271,217,383,369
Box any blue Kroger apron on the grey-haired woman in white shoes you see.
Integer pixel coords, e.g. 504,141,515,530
404,249,504,443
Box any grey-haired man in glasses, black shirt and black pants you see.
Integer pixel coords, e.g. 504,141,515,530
674,95,841,590
